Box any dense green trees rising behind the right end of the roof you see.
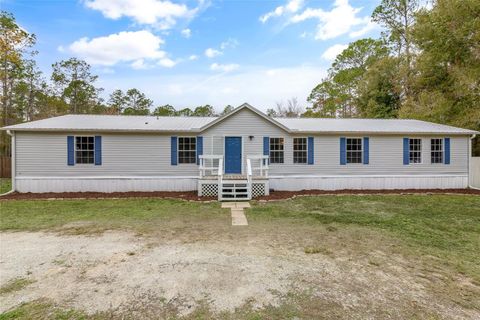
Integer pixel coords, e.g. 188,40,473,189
304,0,480,130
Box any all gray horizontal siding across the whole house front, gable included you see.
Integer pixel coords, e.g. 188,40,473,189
16,109,468,177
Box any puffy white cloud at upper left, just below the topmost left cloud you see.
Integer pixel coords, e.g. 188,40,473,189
64,30,175,69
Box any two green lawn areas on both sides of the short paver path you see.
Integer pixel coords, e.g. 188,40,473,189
0,195,480,283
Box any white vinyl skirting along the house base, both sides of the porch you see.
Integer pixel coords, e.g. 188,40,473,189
16,175,468,193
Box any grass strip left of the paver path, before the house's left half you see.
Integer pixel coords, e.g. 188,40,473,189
0,199,228,234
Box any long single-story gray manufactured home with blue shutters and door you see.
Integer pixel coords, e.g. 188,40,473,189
3,104,478,200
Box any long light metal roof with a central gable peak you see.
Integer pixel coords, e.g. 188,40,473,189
1,103,479,135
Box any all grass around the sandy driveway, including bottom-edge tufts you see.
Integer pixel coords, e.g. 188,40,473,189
0,194,480,319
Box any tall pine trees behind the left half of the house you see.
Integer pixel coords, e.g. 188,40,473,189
0,11,233,155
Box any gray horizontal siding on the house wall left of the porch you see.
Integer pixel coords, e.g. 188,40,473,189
16,132,198,176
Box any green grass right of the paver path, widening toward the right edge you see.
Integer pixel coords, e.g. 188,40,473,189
249,195,480,284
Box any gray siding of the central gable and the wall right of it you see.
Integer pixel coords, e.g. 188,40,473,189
203,110,468,176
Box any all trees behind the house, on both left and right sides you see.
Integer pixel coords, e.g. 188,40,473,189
0,0,480,152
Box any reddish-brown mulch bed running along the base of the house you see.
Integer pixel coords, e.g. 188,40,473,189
0,189,480,201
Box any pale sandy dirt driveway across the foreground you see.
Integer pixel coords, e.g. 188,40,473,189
0,232,480,319
